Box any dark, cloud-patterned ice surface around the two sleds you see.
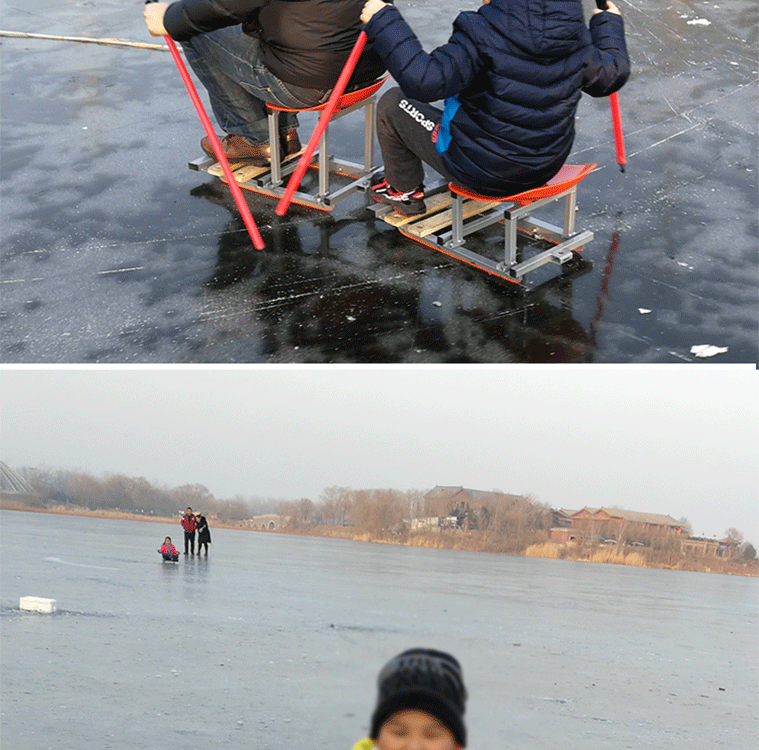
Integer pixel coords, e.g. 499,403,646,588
0,0,759,366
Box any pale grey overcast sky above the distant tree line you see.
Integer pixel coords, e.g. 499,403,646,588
0,365,759,546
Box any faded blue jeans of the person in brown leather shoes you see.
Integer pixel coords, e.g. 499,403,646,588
181,26,329,144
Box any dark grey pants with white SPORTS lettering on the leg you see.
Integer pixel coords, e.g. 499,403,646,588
377,88,453,192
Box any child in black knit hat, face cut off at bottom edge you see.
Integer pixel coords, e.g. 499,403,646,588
354,648,467,750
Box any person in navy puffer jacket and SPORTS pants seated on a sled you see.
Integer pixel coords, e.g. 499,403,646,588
361,0,630,215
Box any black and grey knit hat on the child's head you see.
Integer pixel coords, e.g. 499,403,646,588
370,648,467,747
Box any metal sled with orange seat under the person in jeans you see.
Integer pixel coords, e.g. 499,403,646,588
189,76,387,211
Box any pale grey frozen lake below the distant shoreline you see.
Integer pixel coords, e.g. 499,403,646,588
0,511,759,750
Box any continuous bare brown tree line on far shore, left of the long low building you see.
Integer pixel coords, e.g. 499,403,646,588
21,469,551,551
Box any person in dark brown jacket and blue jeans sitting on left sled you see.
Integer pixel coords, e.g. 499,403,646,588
144,0,384,164
